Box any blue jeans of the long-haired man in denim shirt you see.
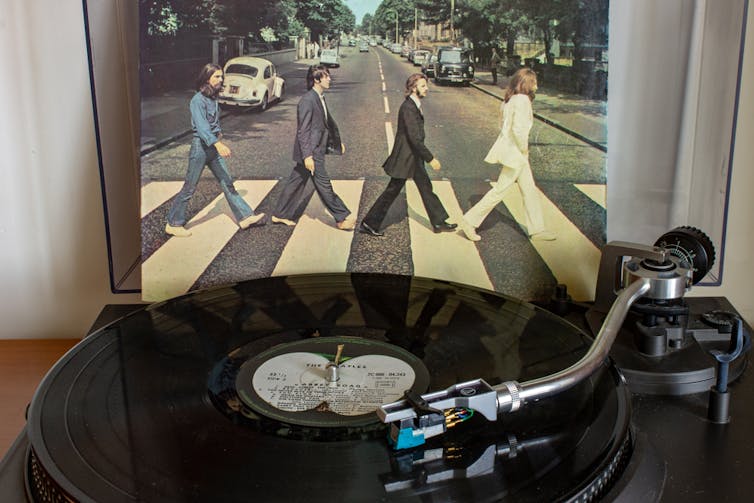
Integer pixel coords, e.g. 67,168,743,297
168,138,254,227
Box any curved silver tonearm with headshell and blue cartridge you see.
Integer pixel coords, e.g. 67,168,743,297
377,242,693,449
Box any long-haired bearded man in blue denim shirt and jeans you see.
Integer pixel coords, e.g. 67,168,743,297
165,63,264,237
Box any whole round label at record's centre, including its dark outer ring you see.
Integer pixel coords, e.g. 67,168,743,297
235,336,429,427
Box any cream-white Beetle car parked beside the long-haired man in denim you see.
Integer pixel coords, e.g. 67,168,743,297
218,56,285,110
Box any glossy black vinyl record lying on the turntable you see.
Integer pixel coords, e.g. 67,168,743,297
28,274,631,503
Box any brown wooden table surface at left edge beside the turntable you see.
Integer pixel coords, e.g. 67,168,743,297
0,339,80,459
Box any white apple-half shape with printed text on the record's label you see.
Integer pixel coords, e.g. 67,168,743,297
252,352,416,416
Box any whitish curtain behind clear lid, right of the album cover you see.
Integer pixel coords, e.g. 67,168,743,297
607,0,747,284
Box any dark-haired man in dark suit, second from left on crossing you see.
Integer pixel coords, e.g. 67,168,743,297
271,66,355,230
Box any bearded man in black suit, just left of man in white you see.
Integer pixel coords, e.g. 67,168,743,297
359,73,456,236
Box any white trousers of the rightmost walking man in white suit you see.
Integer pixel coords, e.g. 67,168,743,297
463,163,545,236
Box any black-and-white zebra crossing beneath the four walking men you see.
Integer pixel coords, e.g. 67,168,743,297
141,179,605,301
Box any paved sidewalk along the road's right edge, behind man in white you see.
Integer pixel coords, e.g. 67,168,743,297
471,71,607,152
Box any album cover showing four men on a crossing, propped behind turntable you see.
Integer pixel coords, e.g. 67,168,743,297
139,0,608,301
